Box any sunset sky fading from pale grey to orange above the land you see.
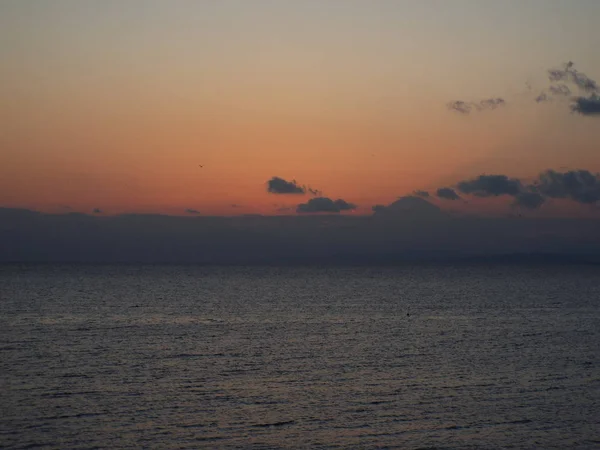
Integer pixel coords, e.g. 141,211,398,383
0,0,600,215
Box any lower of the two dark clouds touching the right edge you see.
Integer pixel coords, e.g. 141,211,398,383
536,170,600,204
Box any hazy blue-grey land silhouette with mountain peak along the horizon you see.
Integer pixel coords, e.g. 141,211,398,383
0,197,600,264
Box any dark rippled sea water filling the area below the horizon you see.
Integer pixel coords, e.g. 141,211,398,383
0,265,600,449
